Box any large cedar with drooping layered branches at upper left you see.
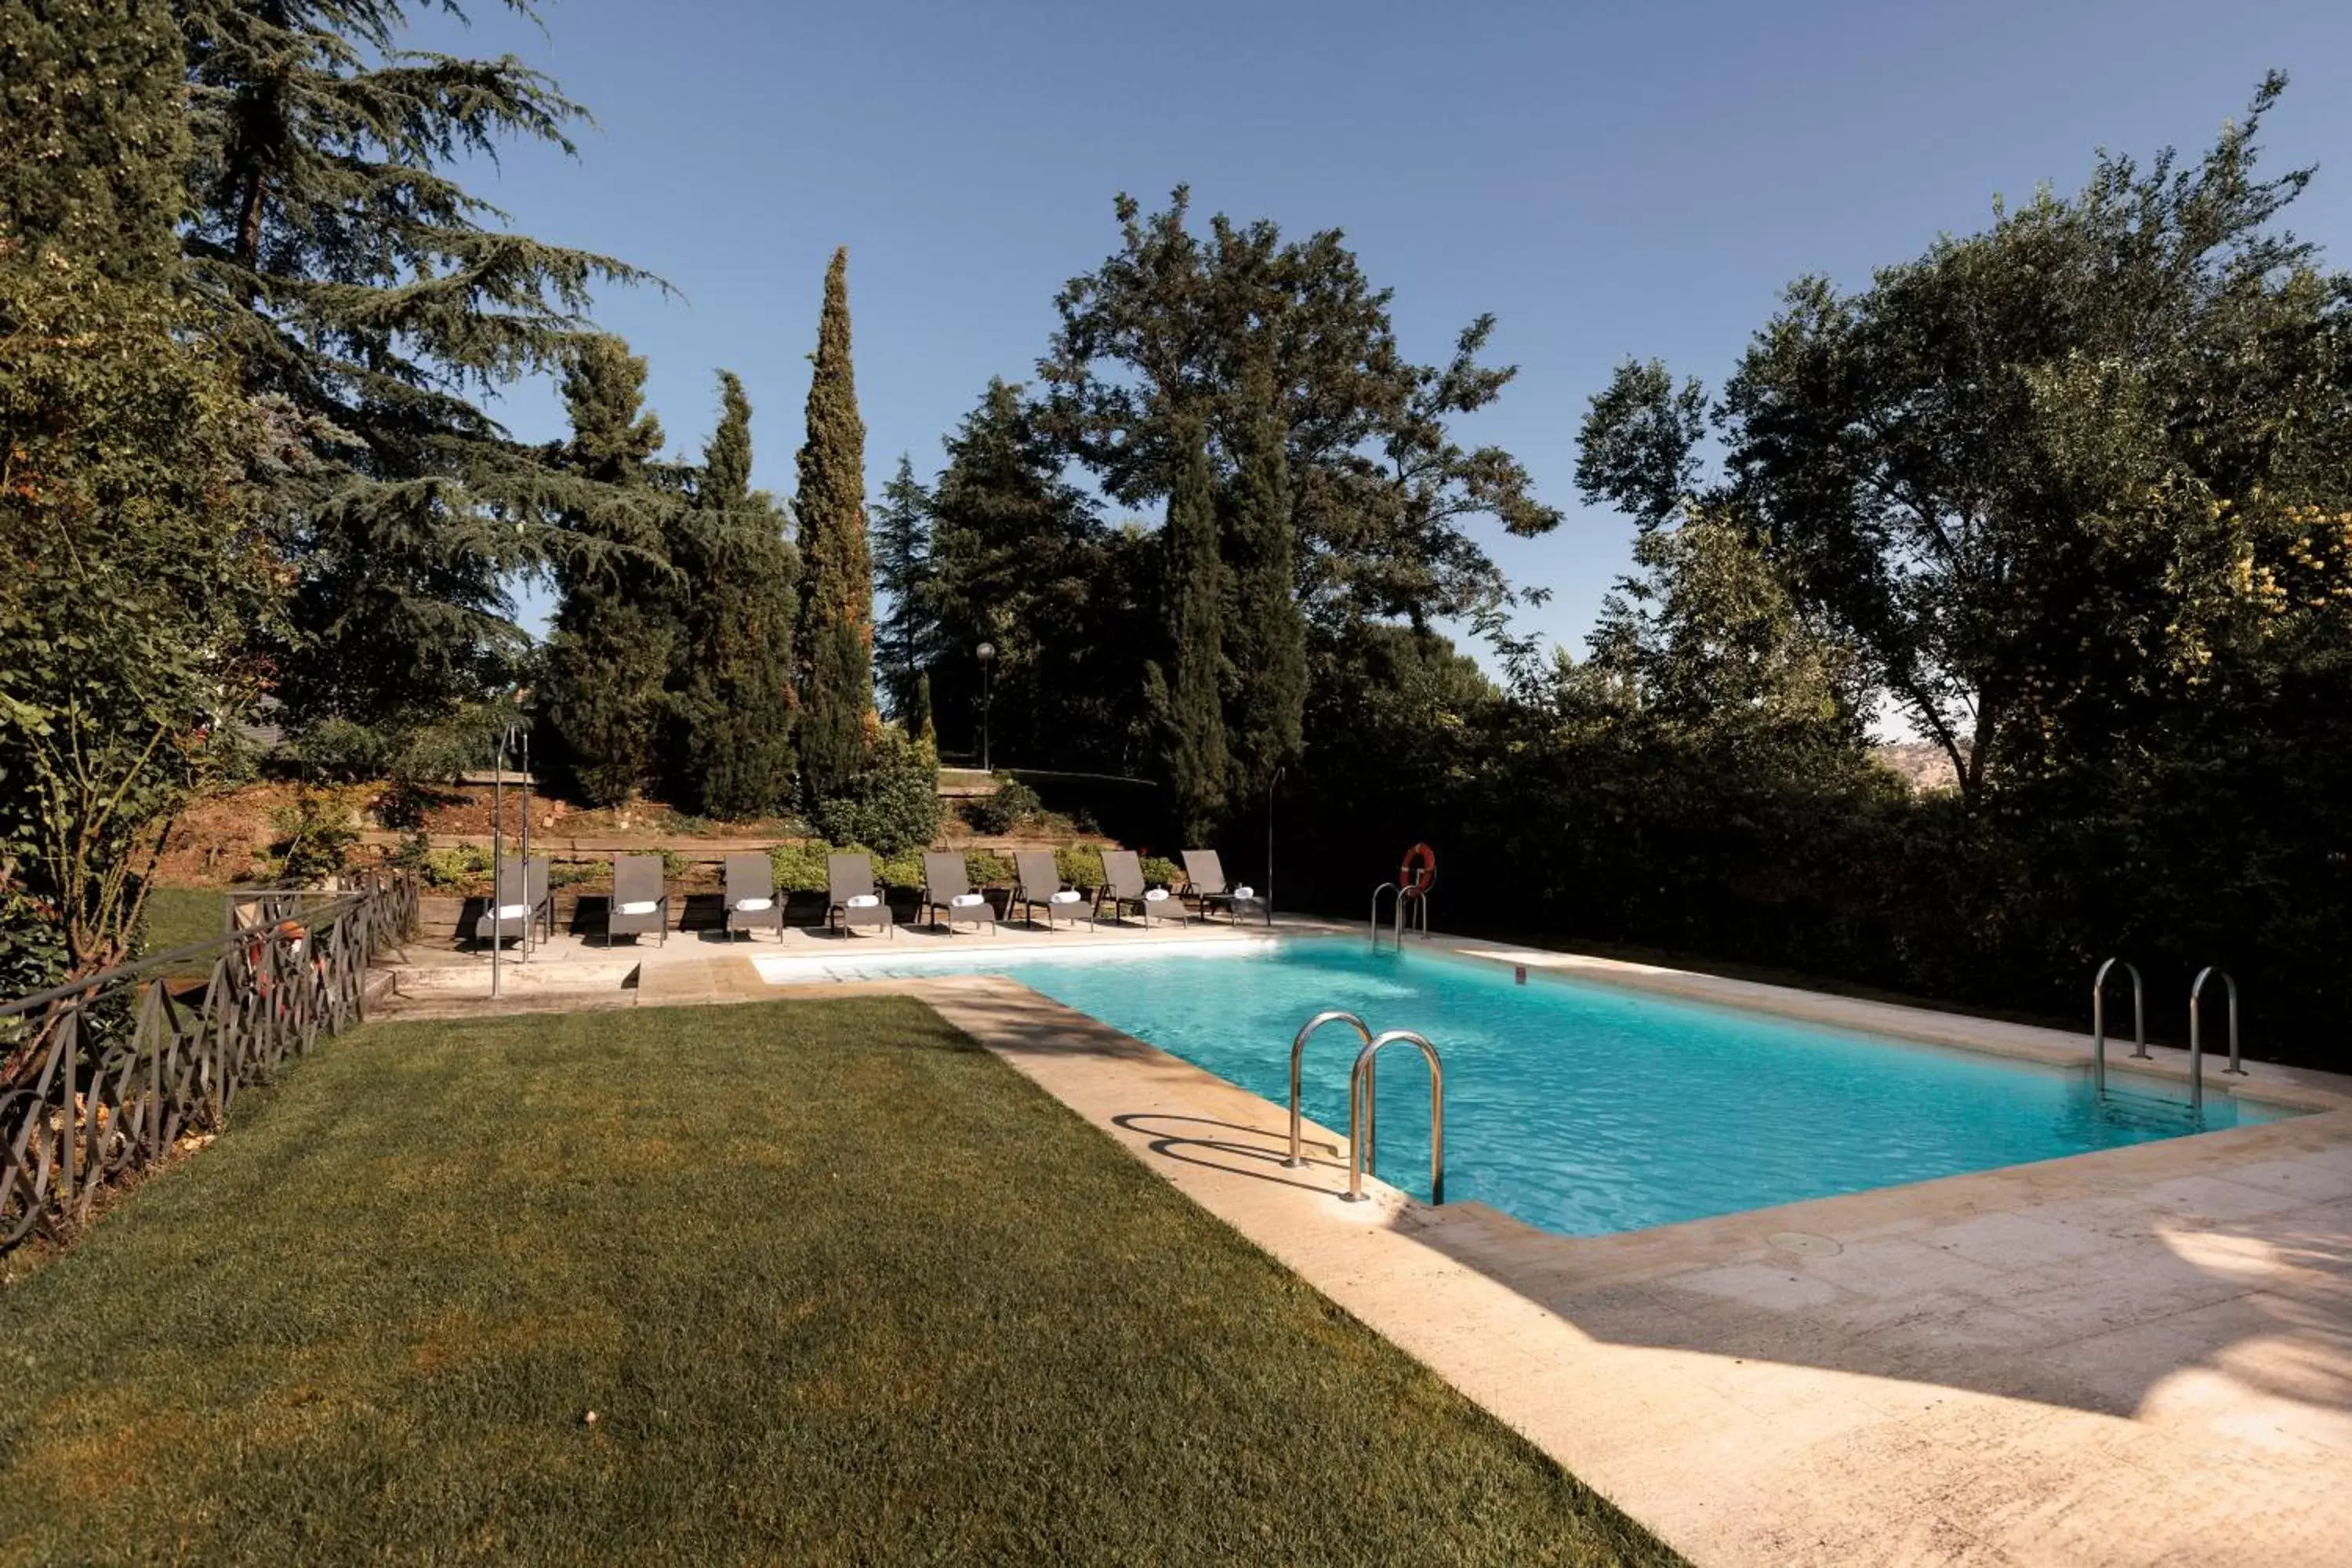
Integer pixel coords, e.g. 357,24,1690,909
174,0,644,761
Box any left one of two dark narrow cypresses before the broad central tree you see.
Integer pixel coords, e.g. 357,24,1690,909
1148,421,1232,844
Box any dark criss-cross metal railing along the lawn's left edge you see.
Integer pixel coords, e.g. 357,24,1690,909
0,872,416,1250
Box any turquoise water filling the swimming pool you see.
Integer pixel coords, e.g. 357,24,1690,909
818,938,2284,1234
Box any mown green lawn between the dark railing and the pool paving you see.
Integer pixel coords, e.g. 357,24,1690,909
0,999,1672,1563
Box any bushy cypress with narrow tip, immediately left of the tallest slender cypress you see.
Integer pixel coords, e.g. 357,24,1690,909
670,372,800,818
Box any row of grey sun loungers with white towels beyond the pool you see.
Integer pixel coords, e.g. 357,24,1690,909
473,848,1251,942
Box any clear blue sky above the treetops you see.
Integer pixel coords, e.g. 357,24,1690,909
416,0,2352,667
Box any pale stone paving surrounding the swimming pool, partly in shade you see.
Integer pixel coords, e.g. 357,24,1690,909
381,921,2352,1568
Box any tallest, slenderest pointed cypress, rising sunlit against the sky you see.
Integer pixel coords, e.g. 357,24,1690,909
793,247,875,801
